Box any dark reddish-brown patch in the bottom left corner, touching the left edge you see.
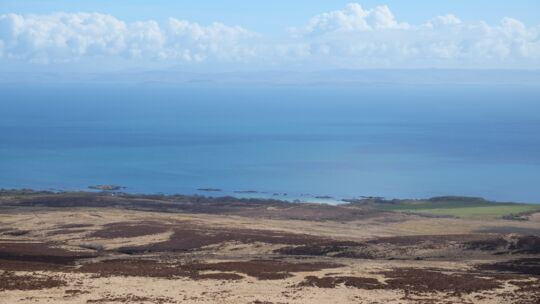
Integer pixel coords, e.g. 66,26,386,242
0,271,67,291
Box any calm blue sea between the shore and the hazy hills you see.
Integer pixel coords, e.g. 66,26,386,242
0,85,540,202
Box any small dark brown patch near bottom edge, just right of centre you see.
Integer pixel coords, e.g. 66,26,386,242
298,276,384,289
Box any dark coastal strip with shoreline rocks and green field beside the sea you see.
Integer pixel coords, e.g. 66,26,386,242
0,185,540,221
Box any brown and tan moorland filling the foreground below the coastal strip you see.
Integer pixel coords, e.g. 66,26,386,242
0,193,540,304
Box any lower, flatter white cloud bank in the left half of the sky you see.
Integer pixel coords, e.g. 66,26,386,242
0,13,253,63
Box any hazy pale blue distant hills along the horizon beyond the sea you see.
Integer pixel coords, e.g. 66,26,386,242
0,69,540,86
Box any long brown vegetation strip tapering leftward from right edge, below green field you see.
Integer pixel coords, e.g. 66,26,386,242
275,234,540,260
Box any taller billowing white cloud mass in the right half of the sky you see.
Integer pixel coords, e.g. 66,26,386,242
291,3,540,68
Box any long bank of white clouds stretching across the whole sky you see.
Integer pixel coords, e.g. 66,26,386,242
0,3,540,69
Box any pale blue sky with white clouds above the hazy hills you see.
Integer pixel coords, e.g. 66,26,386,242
0,0,540,72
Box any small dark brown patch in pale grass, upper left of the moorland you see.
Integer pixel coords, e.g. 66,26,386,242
89,222,169,239
